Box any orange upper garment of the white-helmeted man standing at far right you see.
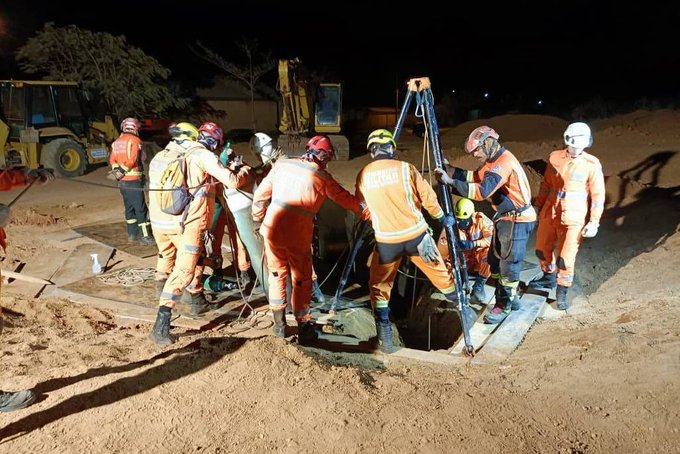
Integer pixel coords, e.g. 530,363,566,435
534,149,605,225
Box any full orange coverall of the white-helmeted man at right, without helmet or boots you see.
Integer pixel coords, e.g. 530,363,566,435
534,149,605,287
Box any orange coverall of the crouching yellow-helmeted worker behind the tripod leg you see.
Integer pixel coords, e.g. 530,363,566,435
437,211,493,278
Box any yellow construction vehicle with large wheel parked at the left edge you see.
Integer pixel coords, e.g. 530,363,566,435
0,80,118,177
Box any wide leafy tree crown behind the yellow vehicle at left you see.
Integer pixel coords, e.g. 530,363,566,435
16,23,188,118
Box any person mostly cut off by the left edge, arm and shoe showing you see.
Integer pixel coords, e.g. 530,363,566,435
0,168,54,411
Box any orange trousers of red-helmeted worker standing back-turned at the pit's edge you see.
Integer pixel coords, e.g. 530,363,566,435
264,238,312,323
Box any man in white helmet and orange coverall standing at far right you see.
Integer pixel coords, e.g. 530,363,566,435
529,122,605,310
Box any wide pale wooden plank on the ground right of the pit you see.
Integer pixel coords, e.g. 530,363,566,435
472,293,545,364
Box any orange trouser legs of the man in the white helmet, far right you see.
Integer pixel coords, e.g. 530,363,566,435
536,218,583,287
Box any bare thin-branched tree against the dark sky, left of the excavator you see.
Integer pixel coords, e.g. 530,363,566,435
194,38,276,131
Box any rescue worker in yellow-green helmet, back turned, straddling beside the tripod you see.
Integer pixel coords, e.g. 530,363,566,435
356,129,475,353
